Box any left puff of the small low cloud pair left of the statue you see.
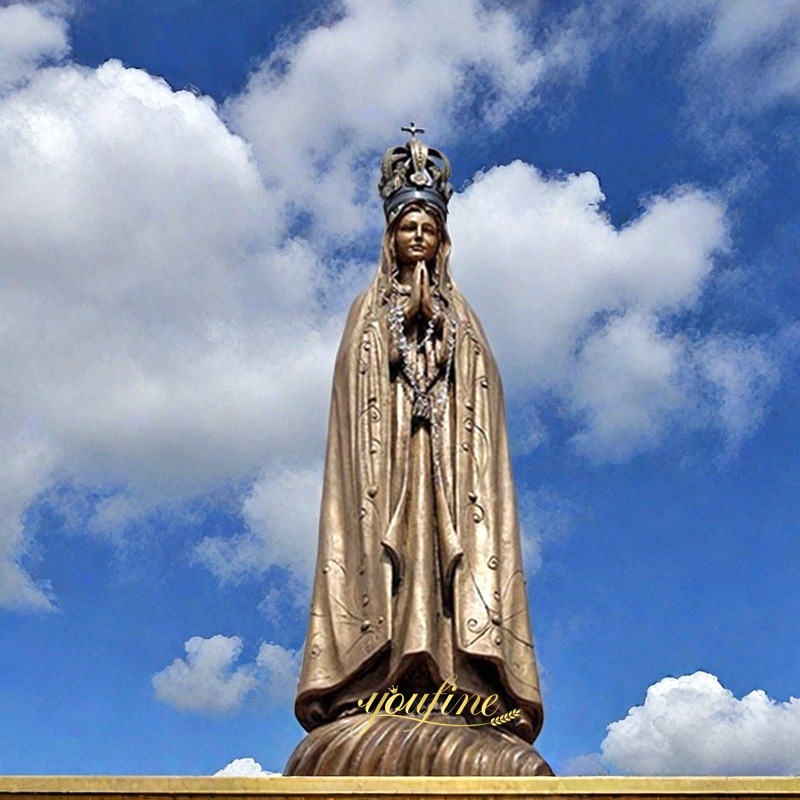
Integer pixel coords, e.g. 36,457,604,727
152,634,258,713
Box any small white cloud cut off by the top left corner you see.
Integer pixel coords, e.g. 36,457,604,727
0,3,69,92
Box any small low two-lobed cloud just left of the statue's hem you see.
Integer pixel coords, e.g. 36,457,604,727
152,634,300,714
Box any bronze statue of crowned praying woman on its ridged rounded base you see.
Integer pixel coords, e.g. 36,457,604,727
286,123,552,775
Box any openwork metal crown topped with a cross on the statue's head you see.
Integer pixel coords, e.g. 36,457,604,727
378,122,453,222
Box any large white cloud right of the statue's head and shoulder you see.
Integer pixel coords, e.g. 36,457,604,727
450,162,777,460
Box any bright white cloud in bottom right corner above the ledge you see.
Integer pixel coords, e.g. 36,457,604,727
571,672,800,775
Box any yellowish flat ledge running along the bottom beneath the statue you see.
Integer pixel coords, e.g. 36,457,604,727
0,775,800,800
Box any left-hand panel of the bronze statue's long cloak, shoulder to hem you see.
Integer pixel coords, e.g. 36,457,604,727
295,283,391,730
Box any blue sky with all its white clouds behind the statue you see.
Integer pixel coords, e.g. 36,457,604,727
0,0,800,775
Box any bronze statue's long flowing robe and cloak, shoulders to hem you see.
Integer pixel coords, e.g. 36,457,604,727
295,264,542,742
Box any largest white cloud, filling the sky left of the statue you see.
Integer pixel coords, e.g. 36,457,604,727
0,48,341,608
